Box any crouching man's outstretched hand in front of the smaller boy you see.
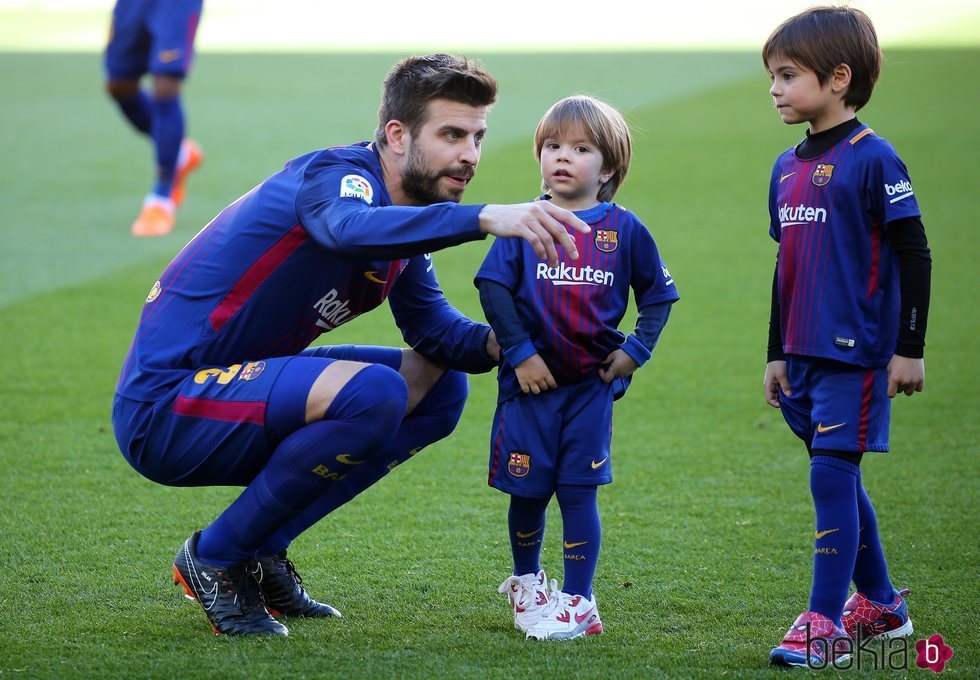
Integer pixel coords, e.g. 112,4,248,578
480,201,592,267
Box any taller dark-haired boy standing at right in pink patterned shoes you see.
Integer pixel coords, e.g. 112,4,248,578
762,7,931,666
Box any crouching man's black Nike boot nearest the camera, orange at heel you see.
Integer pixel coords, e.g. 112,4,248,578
174,531,289,635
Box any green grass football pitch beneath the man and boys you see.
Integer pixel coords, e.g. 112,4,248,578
0,50,980,678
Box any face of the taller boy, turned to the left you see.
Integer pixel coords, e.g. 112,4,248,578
767,55,853,132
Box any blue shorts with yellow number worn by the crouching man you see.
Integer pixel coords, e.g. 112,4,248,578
112,345,401,486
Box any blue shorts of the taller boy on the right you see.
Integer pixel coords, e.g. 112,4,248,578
779,355,891,453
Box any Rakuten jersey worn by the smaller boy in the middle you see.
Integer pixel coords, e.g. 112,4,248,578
476,203,679,399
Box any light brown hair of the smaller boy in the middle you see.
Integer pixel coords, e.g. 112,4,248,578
534,95,633,201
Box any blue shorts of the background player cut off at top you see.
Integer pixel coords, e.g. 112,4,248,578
105,0,203,80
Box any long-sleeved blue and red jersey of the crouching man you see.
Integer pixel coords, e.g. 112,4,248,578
116,143,493,401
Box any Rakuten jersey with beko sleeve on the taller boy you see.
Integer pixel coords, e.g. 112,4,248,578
769,125,920,368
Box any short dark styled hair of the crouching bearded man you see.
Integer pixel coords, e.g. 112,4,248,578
374,53,497,146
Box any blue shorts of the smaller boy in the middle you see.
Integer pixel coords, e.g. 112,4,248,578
488,378,614,498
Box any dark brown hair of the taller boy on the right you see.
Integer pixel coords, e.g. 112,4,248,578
762,7,881,111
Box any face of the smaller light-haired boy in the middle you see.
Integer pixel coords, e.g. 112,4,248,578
541,126,612,210
